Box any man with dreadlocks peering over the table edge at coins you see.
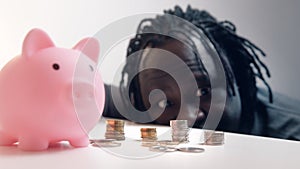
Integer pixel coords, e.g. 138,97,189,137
103,6,300,140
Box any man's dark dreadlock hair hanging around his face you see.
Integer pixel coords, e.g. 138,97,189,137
120,6,273,133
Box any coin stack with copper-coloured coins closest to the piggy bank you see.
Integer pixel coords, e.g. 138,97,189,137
105,119,125,140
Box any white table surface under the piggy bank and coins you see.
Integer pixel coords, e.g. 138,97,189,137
0,118,300,169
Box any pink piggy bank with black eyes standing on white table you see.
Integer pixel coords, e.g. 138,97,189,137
0,29,105,150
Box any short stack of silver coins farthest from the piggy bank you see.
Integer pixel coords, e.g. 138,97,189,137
204,130,224,145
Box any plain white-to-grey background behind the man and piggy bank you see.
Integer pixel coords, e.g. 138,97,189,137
0,0,300,98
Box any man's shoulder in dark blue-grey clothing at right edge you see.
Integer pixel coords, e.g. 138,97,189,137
257,88,300,140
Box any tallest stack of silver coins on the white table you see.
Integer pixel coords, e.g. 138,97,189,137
170,120,189,142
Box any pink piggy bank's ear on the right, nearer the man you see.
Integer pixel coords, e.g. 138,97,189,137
73,38,100,62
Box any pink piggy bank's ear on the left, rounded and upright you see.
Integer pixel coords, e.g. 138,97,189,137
22,29,54,58
